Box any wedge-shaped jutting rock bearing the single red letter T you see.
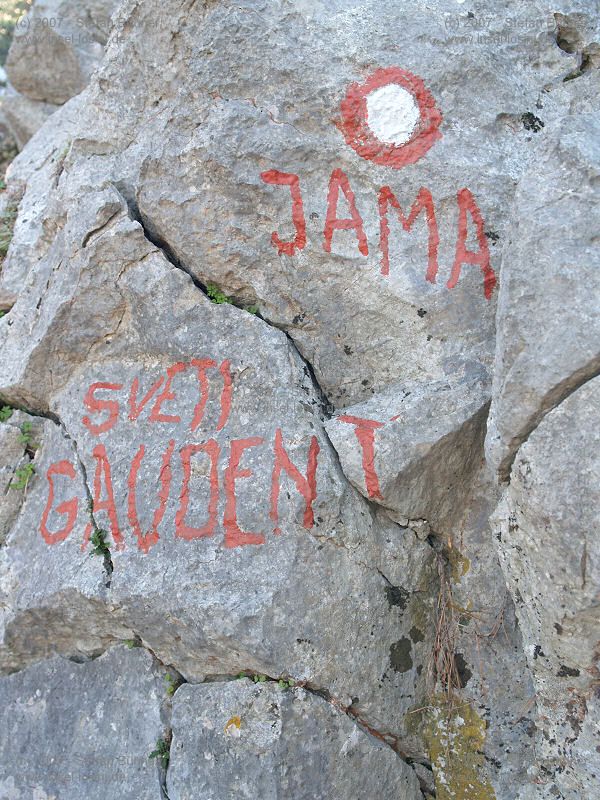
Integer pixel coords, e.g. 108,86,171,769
326,369,489,536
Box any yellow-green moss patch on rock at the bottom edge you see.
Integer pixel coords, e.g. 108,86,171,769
424,694,496,800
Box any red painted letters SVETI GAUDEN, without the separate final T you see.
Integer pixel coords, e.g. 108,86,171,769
40,358,320,553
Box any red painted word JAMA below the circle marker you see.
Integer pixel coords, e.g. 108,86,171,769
260,169,496,300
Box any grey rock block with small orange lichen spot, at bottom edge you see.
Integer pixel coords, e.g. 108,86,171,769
167,680,421,800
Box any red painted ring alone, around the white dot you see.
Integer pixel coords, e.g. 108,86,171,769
340,67,442,169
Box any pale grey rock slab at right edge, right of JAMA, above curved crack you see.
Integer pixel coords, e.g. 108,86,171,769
488,113,600,477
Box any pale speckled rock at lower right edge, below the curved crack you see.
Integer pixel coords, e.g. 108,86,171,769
496,378,600,797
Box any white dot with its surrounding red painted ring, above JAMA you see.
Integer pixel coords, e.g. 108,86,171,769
340,67,442,169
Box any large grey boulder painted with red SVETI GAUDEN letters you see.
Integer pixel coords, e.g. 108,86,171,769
1,188,435,757
